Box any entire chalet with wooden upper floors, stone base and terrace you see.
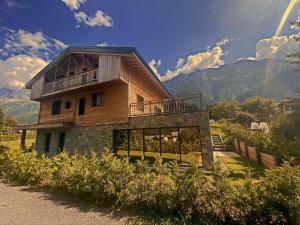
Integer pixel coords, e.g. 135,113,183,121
20,47,212,167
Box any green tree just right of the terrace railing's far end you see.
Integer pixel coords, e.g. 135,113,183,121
210,100,240,120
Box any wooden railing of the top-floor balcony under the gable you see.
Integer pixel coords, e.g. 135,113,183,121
43,70,98,94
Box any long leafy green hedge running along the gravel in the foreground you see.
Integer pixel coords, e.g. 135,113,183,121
0,148,300,224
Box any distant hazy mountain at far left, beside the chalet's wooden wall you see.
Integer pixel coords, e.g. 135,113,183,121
0,98,39,124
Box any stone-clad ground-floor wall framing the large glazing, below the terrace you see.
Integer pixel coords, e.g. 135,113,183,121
36,112,213,167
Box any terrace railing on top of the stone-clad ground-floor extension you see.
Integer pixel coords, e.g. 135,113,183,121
130,94,207,117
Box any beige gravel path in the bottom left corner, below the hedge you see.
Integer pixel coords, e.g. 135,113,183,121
0,182,126,225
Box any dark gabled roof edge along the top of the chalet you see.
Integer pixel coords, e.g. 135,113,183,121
25,46,171,96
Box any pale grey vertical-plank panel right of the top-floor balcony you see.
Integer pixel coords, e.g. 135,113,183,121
98,55,121,83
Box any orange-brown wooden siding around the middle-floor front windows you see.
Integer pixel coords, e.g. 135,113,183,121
39,82,128,125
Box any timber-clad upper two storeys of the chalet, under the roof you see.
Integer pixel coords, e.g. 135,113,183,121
31,51,170,126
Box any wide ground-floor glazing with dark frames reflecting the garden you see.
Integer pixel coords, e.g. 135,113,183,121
114,127,202,164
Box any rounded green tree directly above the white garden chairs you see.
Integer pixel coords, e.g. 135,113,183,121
242,97,278,121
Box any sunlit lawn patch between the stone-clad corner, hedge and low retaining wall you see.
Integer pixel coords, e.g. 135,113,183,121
217,156,264,183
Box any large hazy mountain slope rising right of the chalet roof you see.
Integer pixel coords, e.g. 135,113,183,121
164,60,300,103
